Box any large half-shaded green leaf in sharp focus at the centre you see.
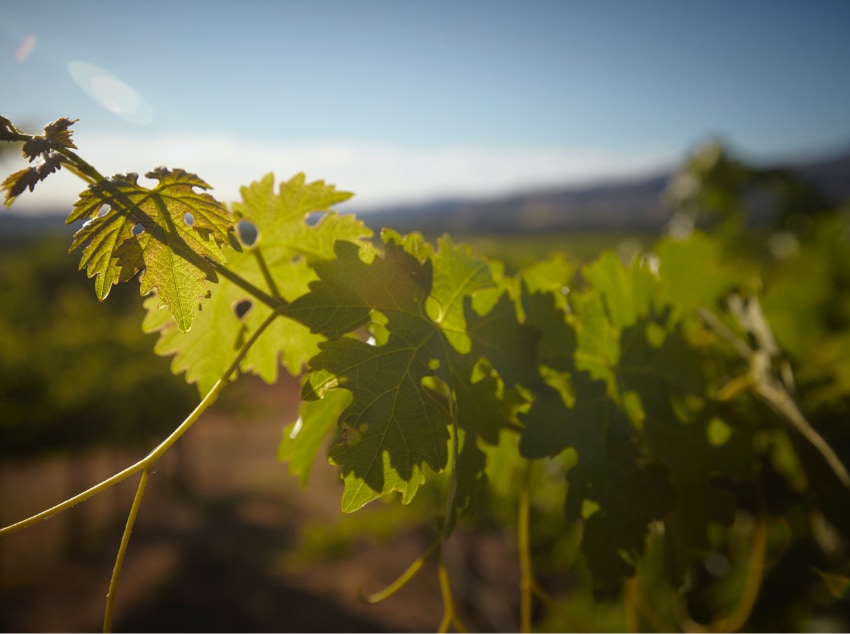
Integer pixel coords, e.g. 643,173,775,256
289,232,535,512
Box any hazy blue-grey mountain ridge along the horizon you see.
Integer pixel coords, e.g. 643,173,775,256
0,148,850,238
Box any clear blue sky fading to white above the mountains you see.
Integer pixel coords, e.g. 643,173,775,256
0,0,850,211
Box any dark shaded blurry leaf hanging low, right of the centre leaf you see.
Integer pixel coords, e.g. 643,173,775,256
520,372,673,593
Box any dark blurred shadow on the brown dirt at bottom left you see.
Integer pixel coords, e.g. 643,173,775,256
115,498,386,632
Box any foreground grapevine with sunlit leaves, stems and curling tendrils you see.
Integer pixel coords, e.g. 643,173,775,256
0,117,850,631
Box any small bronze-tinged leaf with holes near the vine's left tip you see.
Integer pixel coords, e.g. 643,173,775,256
67,168,233,331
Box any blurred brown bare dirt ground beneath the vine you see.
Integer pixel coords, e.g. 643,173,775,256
0,372,518,632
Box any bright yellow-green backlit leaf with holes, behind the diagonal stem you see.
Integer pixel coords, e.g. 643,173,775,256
143,174,371,394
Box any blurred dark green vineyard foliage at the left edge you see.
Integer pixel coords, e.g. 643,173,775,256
0,236,196,458
